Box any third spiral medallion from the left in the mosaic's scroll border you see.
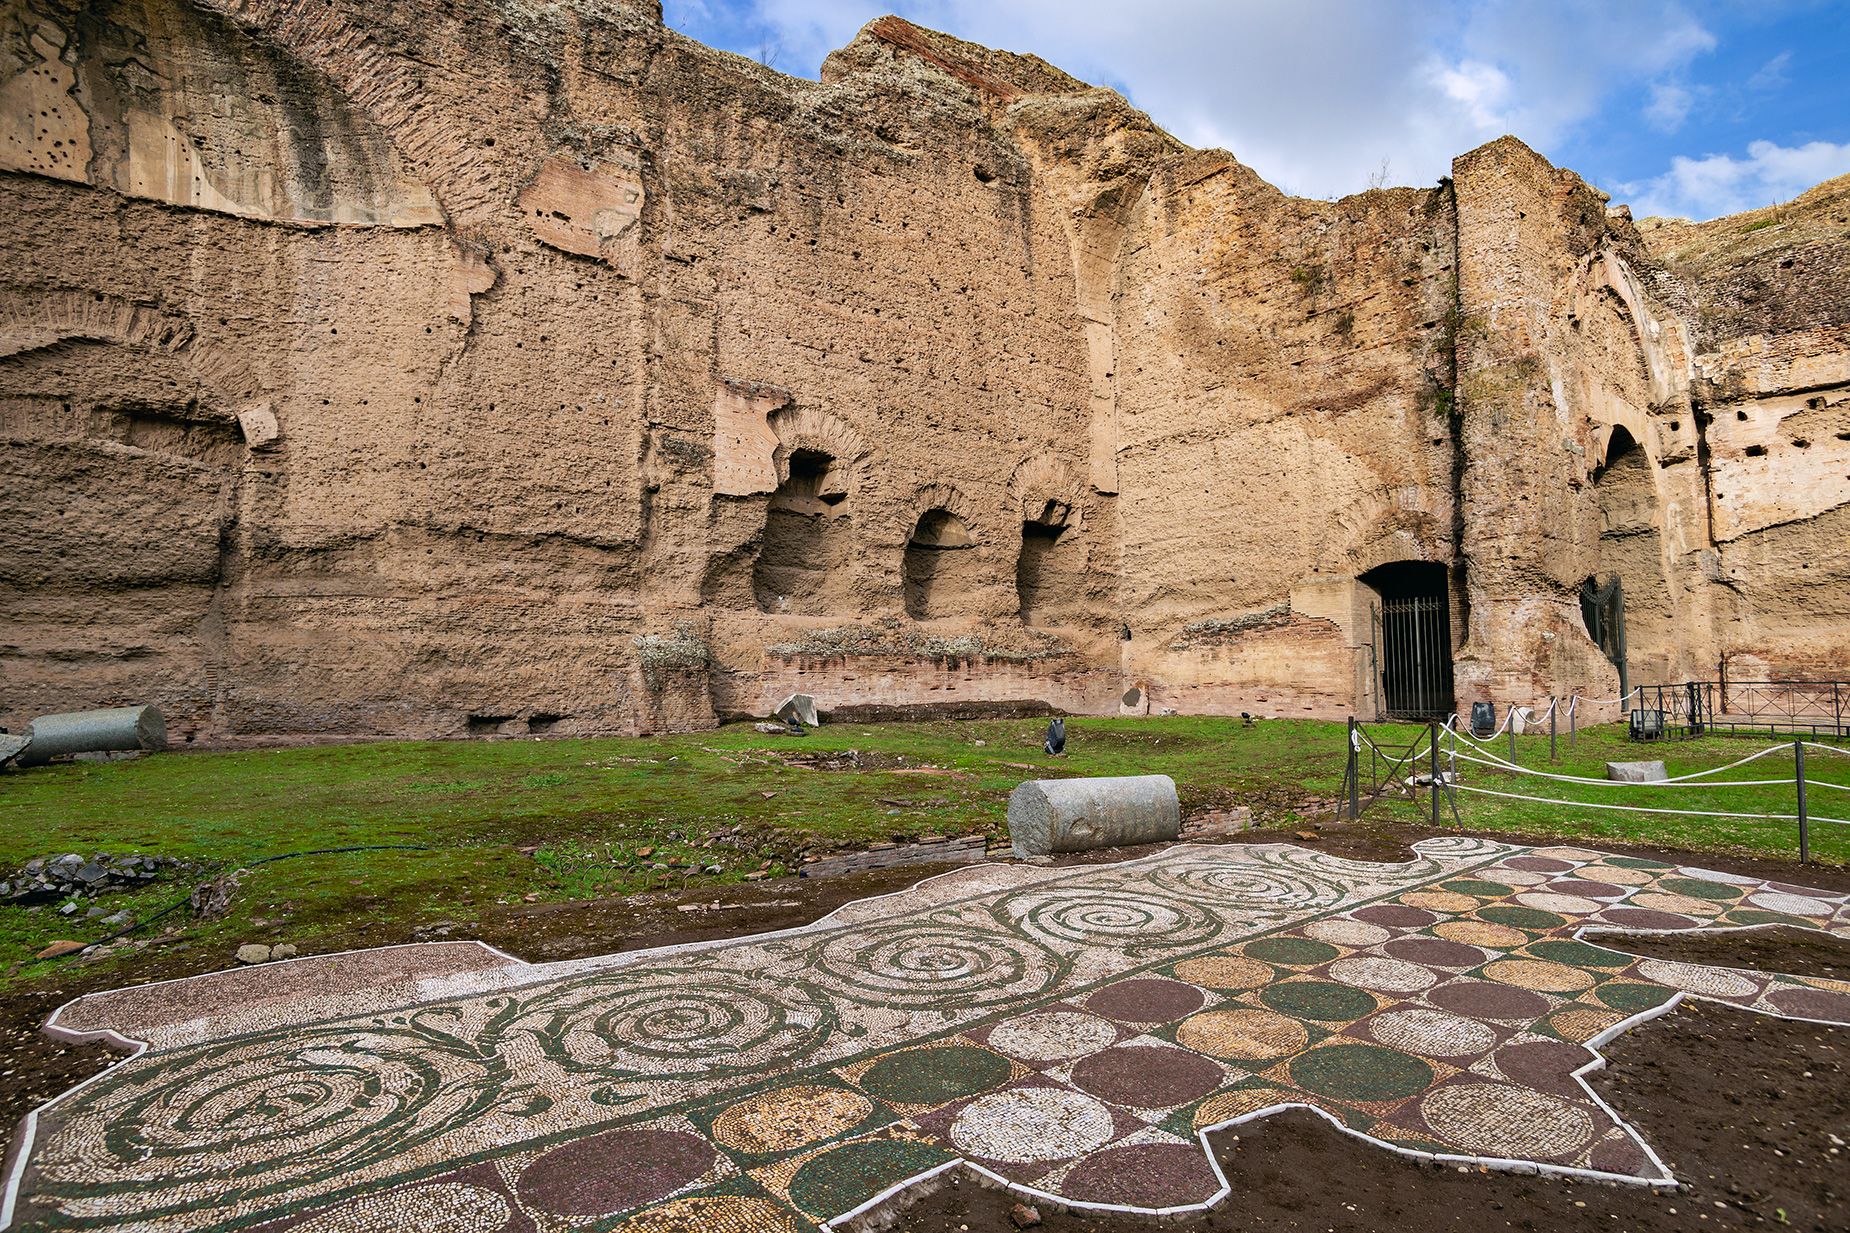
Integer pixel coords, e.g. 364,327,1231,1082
810,920,1064,1009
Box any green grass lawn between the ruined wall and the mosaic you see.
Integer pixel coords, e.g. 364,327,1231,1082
0,716,1850,983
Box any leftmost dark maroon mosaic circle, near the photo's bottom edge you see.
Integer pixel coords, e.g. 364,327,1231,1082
514,1129,716,1216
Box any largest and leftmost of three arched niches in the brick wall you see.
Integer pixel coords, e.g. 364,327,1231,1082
751,448,855,615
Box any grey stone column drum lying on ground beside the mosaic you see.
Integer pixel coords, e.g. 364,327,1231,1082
1008,776,1182,857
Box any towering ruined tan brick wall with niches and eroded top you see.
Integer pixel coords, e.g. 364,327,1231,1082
0,0,1850,742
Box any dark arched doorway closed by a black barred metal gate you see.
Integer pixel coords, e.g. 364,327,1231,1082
1362,561,1452,718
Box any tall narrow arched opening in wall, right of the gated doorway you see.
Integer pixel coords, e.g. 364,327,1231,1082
1580,426,1678,692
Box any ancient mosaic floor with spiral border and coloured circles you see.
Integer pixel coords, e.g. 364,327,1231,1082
0,839,1850,1233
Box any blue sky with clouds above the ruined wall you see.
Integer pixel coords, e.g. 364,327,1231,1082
664,0,1850,218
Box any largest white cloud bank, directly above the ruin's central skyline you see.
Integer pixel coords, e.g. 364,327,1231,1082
706,0,1715,196
